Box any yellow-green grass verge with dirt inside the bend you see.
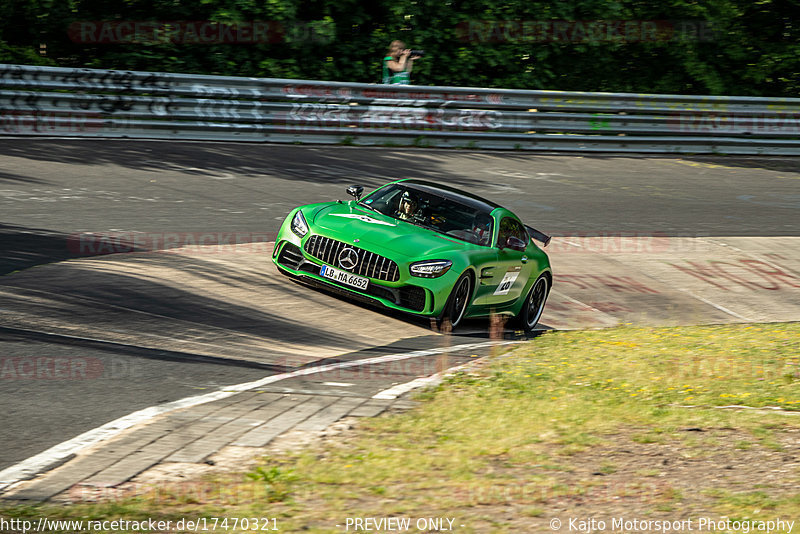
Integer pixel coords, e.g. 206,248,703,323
0,323,800,532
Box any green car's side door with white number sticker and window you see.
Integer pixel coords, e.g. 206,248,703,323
486,216,535,308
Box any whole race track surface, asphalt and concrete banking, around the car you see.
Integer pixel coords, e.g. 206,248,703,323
0,139,800,486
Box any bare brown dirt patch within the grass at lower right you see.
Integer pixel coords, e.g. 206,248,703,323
536,428,800,518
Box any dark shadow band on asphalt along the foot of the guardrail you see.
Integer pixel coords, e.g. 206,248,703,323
0,139,494,187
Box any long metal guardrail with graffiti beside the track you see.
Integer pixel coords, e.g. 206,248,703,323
0,64,800,155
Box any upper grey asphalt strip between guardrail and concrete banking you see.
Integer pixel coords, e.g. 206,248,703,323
0,139,800,250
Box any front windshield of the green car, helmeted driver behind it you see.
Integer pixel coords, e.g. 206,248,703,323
359,183,492,246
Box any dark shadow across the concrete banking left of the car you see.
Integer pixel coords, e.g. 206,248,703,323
0,247,351,352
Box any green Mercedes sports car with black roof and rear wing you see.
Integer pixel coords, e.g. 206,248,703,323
272,179,553,330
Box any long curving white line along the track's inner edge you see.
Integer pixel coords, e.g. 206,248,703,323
0,341,518,492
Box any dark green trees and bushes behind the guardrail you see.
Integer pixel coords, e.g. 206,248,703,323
0,0,800,97
